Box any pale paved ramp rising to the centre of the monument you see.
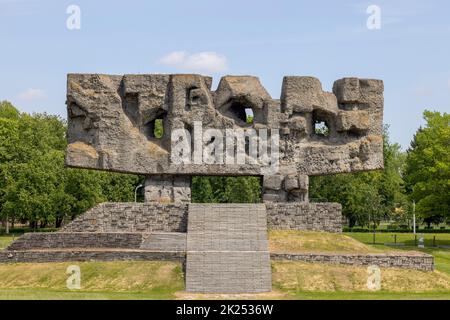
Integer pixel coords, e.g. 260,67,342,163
186,204,272,293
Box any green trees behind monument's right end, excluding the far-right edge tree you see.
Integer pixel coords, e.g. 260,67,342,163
309,127,407,227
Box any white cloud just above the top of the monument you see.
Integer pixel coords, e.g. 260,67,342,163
158,51,228,72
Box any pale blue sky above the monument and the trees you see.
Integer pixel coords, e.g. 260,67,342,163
0,0,450,148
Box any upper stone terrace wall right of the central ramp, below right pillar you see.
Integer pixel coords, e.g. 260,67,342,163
266,202,342,233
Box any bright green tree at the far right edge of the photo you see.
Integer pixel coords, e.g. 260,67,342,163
405,111,450,226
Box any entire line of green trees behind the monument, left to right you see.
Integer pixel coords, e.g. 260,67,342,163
0,101,450,229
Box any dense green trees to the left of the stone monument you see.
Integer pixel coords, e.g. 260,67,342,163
0,102,142,228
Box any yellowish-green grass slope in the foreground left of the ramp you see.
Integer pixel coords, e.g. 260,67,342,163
0,261,184,299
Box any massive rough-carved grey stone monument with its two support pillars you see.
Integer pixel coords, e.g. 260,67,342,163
66,74,383,203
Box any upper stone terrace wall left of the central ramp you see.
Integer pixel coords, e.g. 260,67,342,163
61,202,188,233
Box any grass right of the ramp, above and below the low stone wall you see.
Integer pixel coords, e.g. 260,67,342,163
270,231,450,300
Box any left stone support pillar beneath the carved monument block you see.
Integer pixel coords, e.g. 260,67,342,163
144,175,191,203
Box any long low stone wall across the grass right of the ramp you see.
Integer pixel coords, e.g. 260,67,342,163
270,252,434,271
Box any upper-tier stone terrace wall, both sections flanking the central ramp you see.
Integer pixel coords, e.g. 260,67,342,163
62,202,342,233
